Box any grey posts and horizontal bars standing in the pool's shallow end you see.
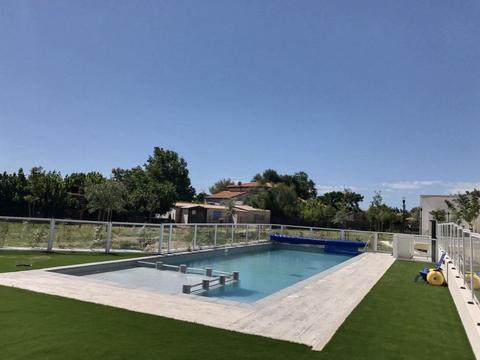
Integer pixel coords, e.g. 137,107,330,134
137,261,240,294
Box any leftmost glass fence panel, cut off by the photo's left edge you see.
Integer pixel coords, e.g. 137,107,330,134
0,219,50,249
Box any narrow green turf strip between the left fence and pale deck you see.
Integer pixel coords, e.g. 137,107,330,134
0,251,145,272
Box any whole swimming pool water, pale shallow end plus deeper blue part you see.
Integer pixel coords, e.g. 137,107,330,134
76,245,353,303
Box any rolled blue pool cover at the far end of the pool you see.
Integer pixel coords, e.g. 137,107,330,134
270,234,365,255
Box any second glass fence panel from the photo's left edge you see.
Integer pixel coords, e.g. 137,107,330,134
53,221,107,250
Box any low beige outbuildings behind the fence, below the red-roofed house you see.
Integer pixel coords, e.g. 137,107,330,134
169,202,270,224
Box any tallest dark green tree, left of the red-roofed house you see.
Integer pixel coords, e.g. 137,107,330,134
145,147,195,201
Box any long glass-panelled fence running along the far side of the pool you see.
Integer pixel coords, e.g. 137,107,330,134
0,216,400,254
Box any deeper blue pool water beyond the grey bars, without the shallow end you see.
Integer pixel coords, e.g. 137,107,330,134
180,249,352,303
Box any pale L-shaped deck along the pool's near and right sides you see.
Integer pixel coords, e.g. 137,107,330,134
0,253,394,350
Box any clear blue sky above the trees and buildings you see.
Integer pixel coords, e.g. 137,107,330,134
0,0,480,207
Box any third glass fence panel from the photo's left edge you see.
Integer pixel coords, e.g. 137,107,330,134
111,224,160,253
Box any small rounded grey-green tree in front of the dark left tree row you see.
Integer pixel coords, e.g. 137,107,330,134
85,180,127,221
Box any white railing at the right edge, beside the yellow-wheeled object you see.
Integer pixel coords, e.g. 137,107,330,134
437,223,480,306
